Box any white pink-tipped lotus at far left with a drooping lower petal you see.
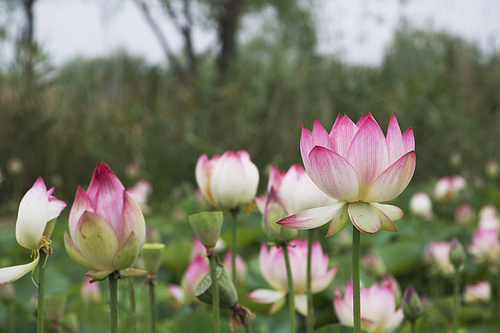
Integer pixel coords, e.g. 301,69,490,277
0,177,66,285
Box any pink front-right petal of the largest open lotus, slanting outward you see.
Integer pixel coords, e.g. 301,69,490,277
365,151,416,202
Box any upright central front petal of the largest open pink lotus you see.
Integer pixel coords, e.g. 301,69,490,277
348,118,389,200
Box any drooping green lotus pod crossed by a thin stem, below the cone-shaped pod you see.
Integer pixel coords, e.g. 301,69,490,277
194,266,238,309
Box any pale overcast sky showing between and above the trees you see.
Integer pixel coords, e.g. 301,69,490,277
0,0,500,65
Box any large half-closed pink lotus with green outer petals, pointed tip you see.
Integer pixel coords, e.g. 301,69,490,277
64,163,146,280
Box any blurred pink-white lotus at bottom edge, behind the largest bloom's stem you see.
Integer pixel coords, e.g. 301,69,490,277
333,281,404,333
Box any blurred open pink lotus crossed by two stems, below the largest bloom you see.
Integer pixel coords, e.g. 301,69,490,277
247,239,337,316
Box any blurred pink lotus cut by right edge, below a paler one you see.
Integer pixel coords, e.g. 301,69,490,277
468,229,500,265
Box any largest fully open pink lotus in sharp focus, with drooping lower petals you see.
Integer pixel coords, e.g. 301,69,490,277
278,113,416,236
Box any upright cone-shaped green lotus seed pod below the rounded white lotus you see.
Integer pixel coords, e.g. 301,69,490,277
189,212,223,255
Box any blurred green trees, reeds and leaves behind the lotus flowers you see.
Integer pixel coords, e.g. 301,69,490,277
0,0,500,332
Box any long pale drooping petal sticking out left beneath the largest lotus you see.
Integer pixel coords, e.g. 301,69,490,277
276,202,345,229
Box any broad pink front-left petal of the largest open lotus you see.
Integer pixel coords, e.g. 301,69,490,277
307,146,359,202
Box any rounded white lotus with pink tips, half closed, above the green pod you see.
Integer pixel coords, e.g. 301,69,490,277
195,150,259,209
